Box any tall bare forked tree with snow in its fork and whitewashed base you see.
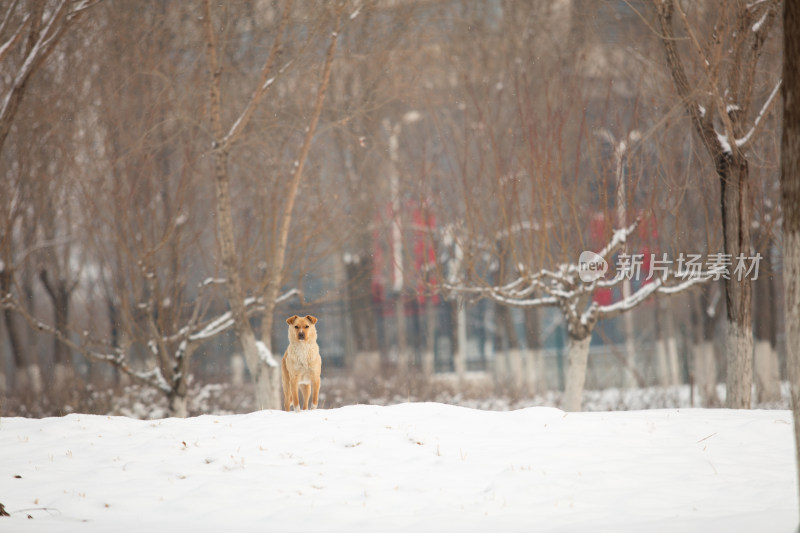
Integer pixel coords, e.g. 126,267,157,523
656,0,780,409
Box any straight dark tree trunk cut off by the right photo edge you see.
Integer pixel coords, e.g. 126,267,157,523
781,2,800,520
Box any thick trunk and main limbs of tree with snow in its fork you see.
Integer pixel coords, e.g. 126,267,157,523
656,0,774,409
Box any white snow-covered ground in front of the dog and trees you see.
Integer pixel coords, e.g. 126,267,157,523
0,403,798,533
